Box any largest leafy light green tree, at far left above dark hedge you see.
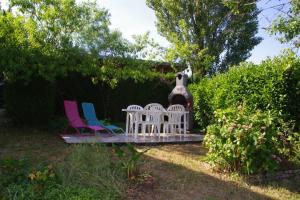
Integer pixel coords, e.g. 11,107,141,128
0,0,115,81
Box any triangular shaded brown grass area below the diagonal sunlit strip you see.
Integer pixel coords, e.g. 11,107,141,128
138,155,271,200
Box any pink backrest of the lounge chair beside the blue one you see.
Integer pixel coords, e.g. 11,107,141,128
64,100,86,127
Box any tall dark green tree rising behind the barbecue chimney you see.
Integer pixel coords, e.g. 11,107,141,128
147,0,261,75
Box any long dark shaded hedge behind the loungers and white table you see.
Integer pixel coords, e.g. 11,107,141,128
5,73,173,125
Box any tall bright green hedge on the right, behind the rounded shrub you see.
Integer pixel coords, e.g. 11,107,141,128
190,55,300,129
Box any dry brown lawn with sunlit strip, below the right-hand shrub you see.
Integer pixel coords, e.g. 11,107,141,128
137,144,300,200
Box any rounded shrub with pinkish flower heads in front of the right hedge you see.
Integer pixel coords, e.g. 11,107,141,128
204,108,283,174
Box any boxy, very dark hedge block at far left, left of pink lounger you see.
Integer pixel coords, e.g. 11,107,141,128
5,78,55,125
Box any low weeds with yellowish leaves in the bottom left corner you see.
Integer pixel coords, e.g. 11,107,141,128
0,158,57,200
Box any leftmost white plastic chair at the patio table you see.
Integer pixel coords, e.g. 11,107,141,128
126,105,143,134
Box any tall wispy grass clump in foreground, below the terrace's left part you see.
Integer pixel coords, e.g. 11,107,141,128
58,144,126,199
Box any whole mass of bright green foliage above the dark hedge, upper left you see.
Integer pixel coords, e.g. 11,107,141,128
0,0,171,86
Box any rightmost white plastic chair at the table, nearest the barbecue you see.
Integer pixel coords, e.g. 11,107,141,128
163,104,185,134
